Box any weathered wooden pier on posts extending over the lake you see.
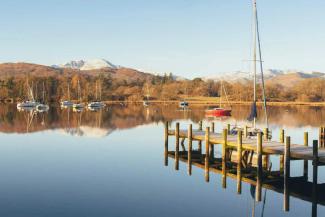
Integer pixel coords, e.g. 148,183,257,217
165,122,325,216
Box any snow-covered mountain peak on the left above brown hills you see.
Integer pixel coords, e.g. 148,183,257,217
53,59,118,70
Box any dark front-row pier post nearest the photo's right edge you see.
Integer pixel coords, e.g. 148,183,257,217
312,140,318,216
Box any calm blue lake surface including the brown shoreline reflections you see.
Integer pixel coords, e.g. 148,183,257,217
0,105,325,217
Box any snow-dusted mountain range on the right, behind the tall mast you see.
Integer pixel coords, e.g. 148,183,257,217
203,69,325,82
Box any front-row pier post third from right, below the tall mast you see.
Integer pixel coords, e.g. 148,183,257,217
255,132,263,202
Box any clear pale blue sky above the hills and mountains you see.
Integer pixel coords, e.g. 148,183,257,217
0,0,325,77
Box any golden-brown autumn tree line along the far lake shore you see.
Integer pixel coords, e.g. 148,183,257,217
0,74,325,102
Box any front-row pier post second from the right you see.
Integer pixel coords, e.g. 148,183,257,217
283,136,291,212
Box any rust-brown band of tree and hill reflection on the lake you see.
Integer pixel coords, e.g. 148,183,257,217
0,104,325,136
